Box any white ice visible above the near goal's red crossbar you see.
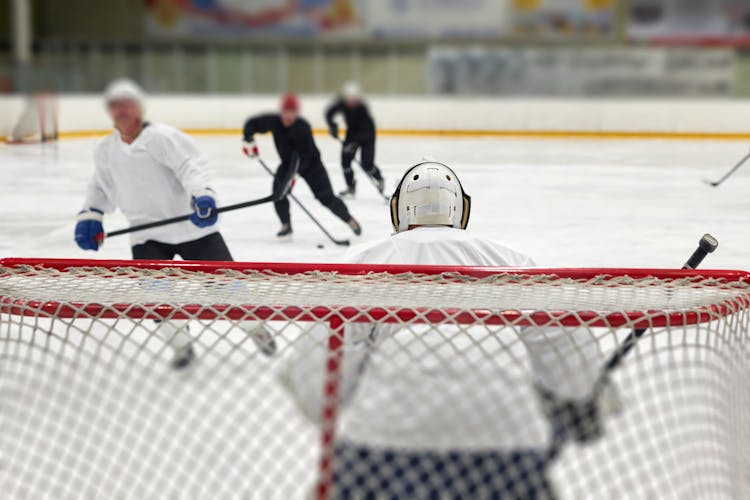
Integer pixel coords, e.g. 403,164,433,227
0,136,750,269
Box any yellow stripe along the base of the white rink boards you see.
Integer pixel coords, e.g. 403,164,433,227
0,128,750,141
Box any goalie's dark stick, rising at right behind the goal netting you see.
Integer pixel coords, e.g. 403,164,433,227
544,234,719,462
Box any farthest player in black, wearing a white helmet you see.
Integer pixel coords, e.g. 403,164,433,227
326,82,385,196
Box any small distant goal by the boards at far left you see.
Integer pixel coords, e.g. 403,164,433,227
6,94,58,144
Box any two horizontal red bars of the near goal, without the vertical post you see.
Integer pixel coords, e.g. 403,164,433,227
0,258,750,328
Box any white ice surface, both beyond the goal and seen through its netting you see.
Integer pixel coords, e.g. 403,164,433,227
0,136,750,498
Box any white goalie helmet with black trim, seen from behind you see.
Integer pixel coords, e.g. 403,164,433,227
391,160,471,233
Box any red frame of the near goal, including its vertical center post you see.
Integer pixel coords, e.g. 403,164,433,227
0,258,750,500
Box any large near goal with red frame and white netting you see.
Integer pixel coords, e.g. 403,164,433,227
0,259,750,499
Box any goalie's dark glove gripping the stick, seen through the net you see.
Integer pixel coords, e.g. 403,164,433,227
536,379,621,443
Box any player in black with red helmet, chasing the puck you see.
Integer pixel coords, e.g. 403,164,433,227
243,94,362,237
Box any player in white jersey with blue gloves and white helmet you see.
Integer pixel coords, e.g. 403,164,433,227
75,79,274,368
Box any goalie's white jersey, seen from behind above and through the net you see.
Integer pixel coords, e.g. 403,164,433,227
286,227,601,450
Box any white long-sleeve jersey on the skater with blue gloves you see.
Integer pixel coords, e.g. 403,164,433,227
83,123,217,245
